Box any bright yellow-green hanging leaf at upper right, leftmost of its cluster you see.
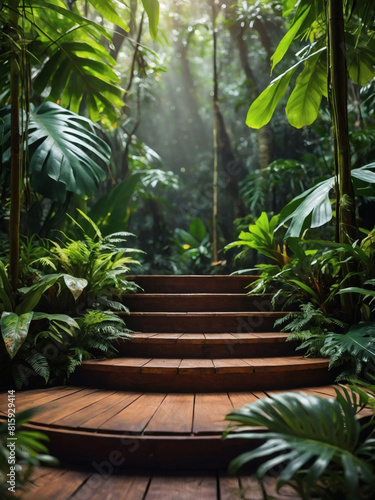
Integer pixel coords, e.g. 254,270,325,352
246,65,297,129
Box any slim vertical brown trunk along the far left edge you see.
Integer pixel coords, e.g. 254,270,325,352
9,0,21,290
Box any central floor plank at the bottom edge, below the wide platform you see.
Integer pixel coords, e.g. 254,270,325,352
144,476,218,500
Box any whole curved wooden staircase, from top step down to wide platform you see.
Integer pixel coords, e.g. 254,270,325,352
0,276,334,473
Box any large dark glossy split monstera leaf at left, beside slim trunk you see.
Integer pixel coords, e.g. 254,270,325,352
29,102,110,202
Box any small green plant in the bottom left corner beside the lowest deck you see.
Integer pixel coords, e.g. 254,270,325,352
0,409,58,500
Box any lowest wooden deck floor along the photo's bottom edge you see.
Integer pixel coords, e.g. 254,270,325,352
22,461,300,500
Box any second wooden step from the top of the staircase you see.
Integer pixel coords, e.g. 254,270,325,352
123,293,273,312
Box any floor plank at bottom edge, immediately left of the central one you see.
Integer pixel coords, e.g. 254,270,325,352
71,474,150,500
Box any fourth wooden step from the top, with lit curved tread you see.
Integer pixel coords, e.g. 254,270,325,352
122,332,301,359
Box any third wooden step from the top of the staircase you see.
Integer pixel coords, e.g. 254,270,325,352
124,311,287,333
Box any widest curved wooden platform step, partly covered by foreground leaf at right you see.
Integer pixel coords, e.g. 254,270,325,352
0,386,340,474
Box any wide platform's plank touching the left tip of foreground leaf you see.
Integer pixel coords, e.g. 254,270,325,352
193,392,233,434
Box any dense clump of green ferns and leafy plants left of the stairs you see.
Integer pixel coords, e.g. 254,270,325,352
0,212,137,387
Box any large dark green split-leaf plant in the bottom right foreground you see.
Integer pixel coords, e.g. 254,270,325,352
225,383,375,500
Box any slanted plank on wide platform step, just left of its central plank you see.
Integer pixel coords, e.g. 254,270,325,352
100,393,166,434
